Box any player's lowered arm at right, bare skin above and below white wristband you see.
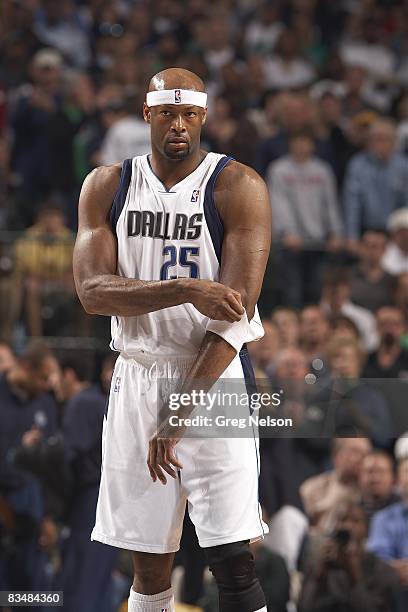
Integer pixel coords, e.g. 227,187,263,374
147,162,272,484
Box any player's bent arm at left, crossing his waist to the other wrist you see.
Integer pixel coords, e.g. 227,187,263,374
73,165,242,322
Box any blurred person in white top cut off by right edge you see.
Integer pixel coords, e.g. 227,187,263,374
382,207,408,275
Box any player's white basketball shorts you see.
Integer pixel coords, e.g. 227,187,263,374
91,353,268,553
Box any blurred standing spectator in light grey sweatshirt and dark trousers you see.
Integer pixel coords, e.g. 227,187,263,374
268,134,342,308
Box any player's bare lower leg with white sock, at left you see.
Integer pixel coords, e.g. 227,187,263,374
128,552,174,612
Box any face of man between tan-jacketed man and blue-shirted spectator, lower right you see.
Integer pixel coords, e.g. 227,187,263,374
360,449,400,521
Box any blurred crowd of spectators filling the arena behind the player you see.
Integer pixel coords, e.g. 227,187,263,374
0,0,408,612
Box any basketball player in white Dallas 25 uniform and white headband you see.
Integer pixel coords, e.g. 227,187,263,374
74,68,271,612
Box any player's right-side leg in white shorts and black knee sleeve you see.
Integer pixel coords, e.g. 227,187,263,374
177,355,267,612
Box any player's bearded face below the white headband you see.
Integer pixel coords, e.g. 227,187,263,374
144,104,206,161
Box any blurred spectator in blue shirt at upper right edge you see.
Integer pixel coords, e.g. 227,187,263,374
344,119,408,243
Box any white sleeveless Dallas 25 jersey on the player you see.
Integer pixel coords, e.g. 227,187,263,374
111,153,255,357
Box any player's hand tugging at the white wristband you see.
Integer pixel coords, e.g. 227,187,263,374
191,280,245,323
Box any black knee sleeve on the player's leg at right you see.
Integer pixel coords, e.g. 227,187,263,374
205,541,266,612
